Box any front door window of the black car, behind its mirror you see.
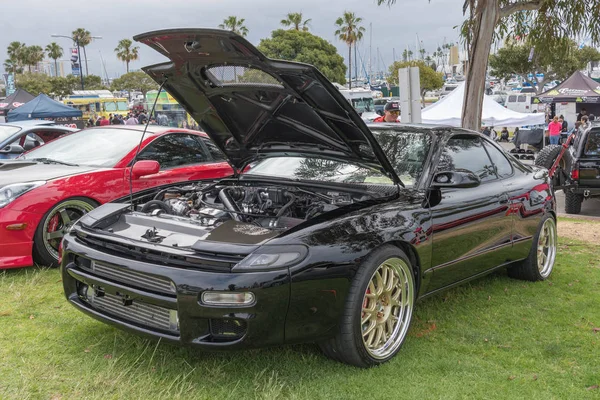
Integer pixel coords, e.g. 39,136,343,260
437,135,498,182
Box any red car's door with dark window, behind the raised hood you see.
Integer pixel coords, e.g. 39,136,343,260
133,133,232,191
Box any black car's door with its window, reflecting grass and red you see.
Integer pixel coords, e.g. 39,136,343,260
429,133,512,290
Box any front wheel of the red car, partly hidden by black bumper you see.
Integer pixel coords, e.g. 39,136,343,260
33,197,98,267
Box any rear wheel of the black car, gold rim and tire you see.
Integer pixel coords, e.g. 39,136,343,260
508,214,558,282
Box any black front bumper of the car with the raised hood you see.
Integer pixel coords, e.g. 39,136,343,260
61,234,290,349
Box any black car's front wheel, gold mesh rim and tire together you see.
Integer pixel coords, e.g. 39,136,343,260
320,246,415,368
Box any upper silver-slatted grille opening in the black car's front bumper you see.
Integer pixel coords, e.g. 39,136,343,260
75,257,177,295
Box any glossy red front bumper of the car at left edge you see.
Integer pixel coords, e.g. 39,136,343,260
0,208,41,269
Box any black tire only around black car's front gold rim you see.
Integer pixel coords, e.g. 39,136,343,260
348,245,416,365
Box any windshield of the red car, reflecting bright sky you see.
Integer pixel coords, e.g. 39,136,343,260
20,128,142,167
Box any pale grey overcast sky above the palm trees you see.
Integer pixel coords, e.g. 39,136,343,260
0,0,463,77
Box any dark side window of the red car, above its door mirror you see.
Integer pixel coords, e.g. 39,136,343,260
138,134,209,169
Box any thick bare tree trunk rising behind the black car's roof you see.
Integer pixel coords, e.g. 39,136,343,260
462,0,500,131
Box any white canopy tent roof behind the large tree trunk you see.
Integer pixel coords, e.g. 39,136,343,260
421,82,546,126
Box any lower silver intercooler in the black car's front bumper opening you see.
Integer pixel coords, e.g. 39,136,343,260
86,290,179,334
